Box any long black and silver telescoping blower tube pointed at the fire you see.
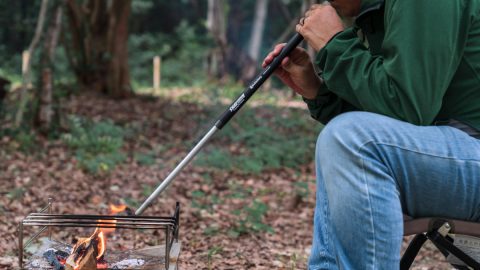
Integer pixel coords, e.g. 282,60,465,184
135,33,303,215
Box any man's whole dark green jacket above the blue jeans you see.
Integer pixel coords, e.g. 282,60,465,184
305,0,480,130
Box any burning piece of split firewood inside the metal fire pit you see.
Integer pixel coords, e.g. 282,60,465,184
65,236,98,270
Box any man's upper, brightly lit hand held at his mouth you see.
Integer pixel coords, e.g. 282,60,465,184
296,2,344,52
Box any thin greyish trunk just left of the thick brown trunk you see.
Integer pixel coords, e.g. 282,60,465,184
35,0,63,134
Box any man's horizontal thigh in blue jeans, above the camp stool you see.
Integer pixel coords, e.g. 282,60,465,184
330,112,480,221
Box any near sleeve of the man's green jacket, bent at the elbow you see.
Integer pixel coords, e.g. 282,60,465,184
317,0,469,125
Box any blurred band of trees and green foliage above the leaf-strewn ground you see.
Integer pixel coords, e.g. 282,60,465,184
0,0,314,92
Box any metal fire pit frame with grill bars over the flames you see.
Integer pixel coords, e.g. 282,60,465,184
18,199,180,270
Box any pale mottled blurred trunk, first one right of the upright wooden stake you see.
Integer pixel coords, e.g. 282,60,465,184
207,0,228,79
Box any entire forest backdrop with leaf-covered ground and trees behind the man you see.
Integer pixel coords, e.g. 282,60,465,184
0,0,450,269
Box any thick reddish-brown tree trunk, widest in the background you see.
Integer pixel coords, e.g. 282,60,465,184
65,0,133,98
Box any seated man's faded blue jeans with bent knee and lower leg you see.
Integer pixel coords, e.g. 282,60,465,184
309,112,480,270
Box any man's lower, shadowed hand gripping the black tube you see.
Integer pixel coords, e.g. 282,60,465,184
262,44,321,99
